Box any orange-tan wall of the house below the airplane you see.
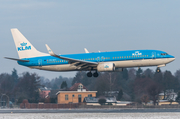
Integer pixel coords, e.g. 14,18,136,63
57,91,96,104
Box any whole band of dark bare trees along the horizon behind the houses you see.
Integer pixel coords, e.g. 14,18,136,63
0,68,180,104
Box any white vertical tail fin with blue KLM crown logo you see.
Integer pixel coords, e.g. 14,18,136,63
11,28,48,59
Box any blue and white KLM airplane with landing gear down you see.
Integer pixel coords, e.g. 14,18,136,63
5,28,175,77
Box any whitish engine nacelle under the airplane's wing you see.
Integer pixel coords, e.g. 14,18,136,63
97,63,115,72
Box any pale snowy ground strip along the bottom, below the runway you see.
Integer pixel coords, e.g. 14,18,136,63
0,112,180,119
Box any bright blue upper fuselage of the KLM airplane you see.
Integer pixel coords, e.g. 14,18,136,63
18,50,174,67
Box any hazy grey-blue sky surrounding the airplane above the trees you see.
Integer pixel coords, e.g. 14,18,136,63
0,0,180,79
